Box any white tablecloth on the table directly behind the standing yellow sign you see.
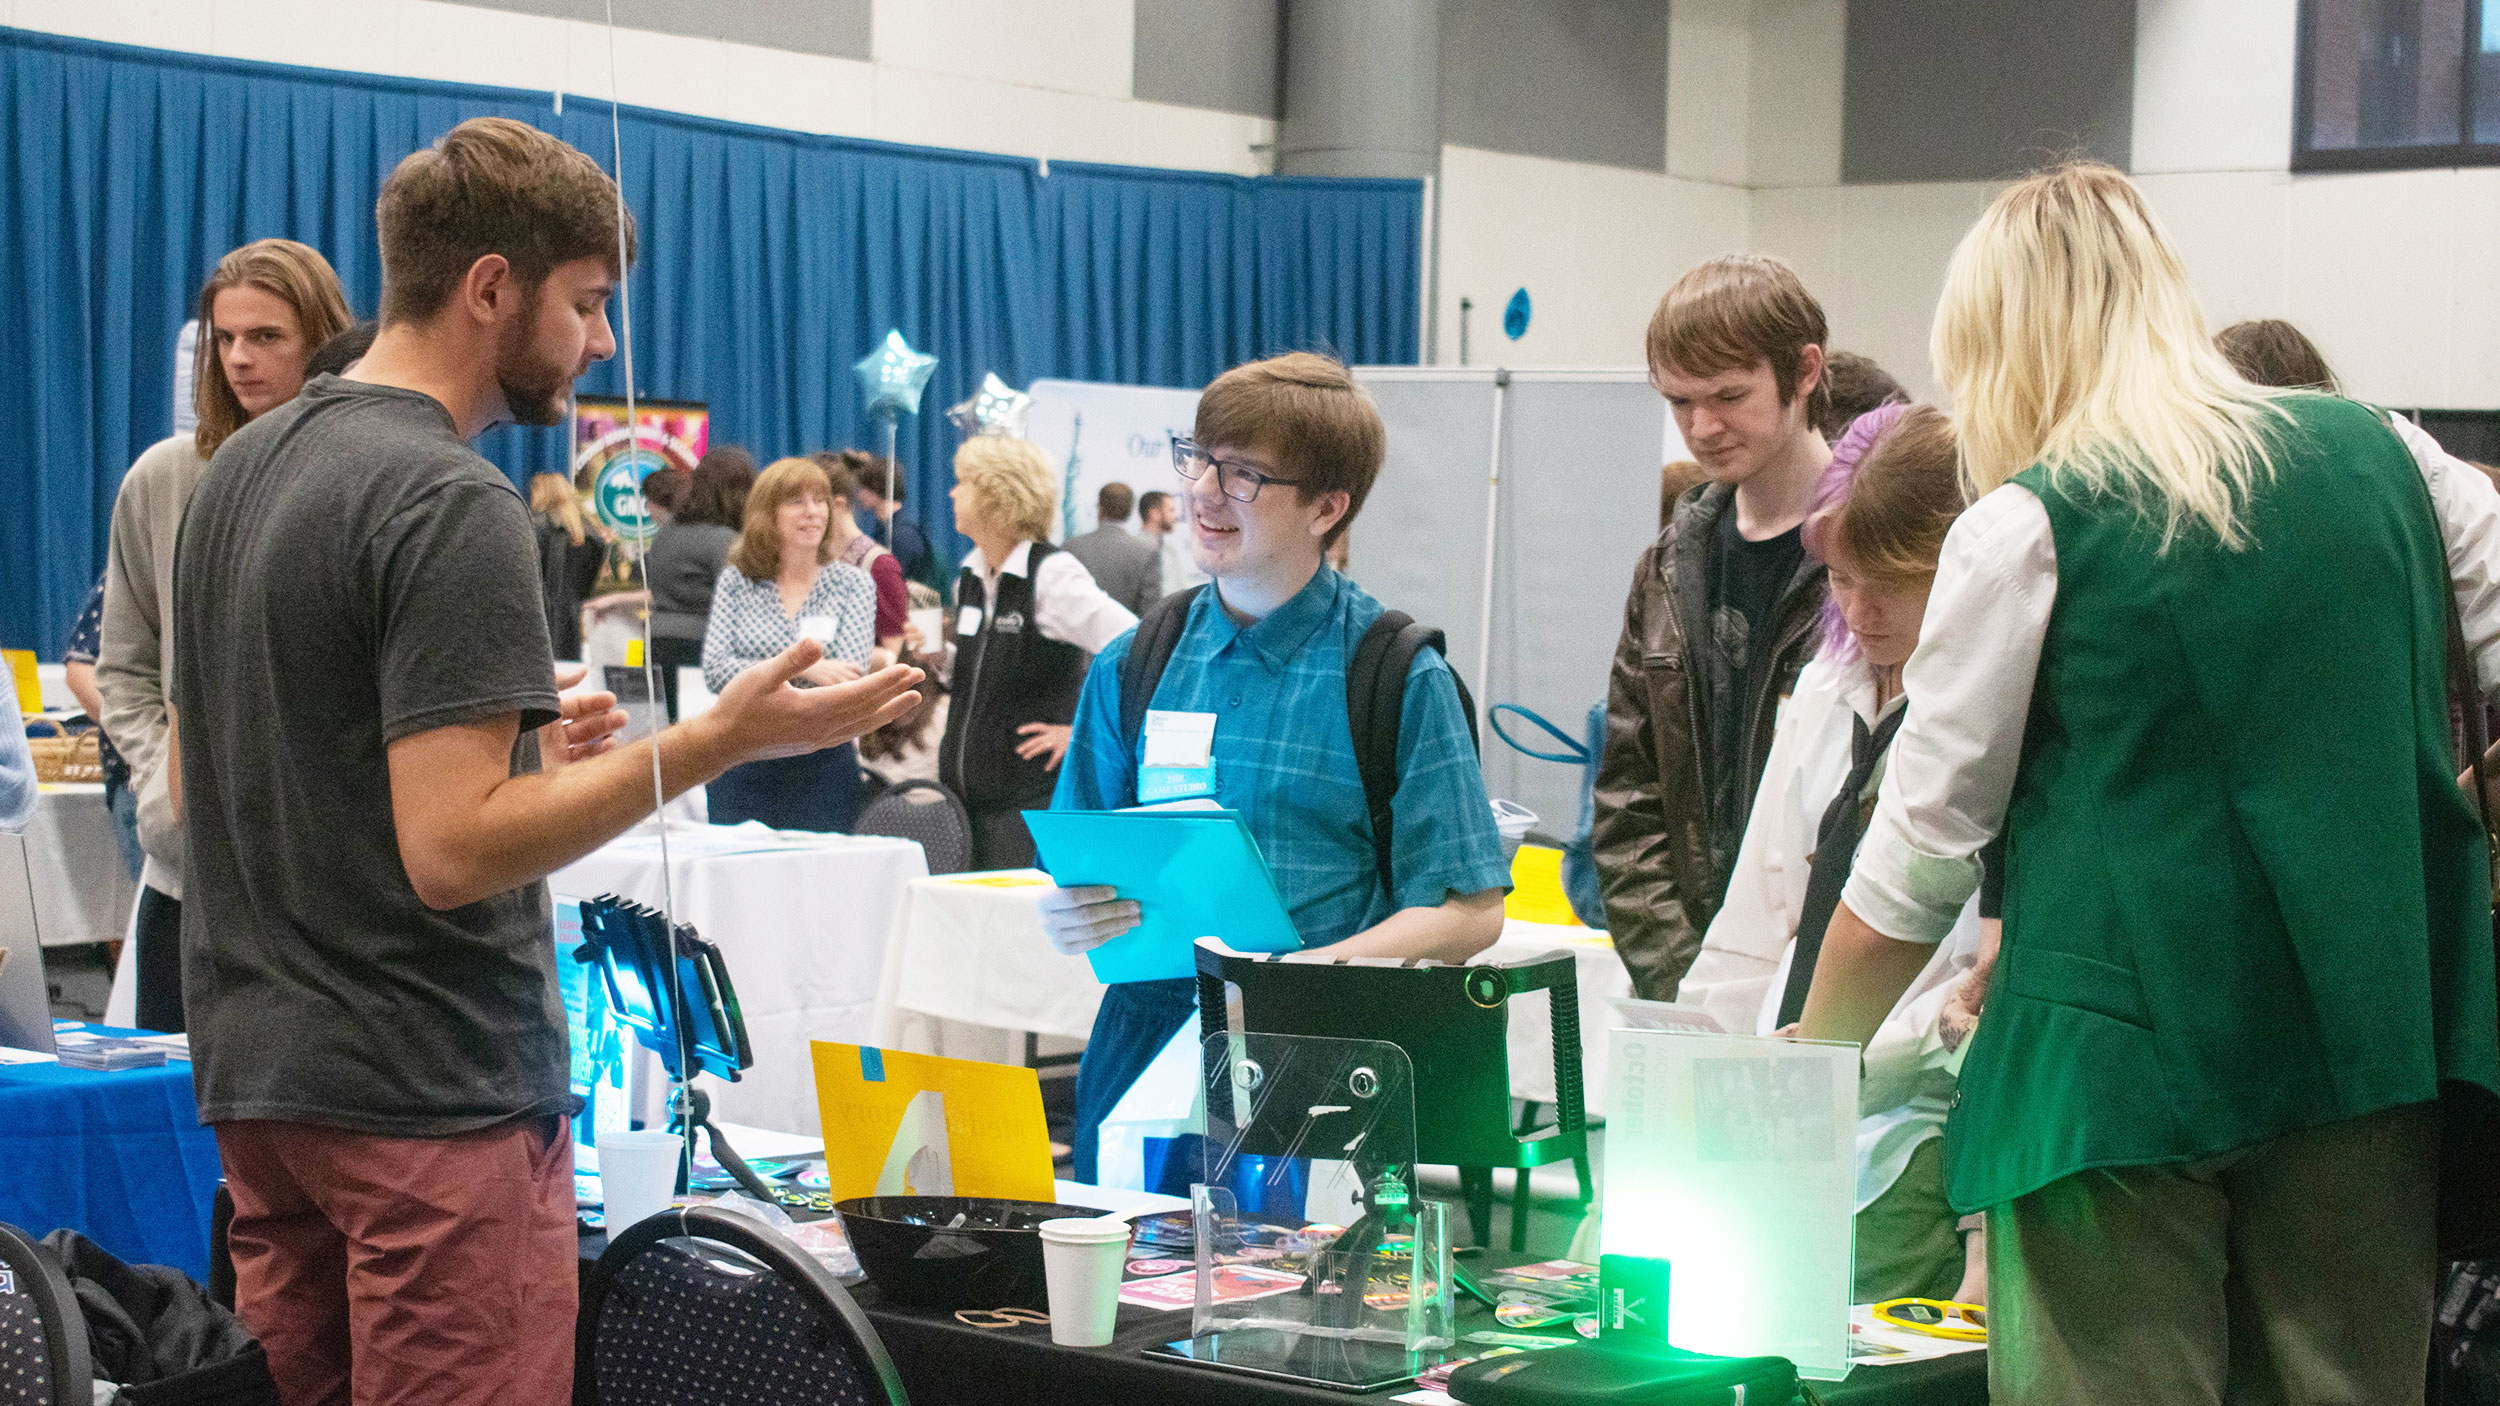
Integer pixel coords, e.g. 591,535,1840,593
548,823,928,1136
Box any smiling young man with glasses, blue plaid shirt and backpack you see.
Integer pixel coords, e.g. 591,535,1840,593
1043,353,1510,1181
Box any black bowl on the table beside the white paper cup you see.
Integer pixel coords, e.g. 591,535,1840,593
835,1196,1103,1311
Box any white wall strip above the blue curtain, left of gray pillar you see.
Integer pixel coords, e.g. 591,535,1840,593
0,0,1275,175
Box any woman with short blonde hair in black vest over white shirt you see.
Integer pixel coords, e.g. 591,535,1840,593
938,435,1138,868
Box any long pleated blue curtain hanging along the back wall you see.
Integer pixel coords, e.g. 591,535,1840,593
0,28,1423,658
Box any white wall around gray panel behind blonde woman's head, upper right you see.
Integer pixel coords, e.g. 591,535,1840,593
1750,0,2500,408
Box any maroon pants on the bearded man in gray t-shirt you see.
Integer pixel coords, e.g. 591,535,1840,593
218,1116,580,1406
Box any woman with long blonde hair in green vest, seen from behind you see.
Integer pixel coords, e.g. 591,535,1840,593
1800,165,2500,1406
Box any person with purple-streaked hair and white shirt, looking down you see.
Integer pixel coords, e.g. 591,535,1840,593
1678,405,1988,1303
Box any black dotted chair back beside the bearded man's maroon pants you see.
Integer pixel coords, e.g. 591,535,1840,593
573,1206,908,1406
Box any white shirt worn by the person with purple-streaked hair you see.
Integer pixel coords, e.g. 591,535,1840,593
1675,655,1980,1211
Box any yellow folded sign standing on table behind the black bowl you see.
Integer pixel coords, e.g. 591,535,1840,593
813,1041,1053,1201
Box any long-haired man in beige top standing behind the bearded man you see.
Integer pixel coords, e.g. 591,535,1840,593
95,240,353,1031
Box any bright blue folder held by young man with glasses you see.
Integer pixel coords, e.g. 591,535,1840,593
1025,811,1303,986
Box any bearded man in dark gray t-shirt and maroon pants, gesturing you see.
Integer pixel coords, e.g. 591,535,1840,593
168,118,920,1406
